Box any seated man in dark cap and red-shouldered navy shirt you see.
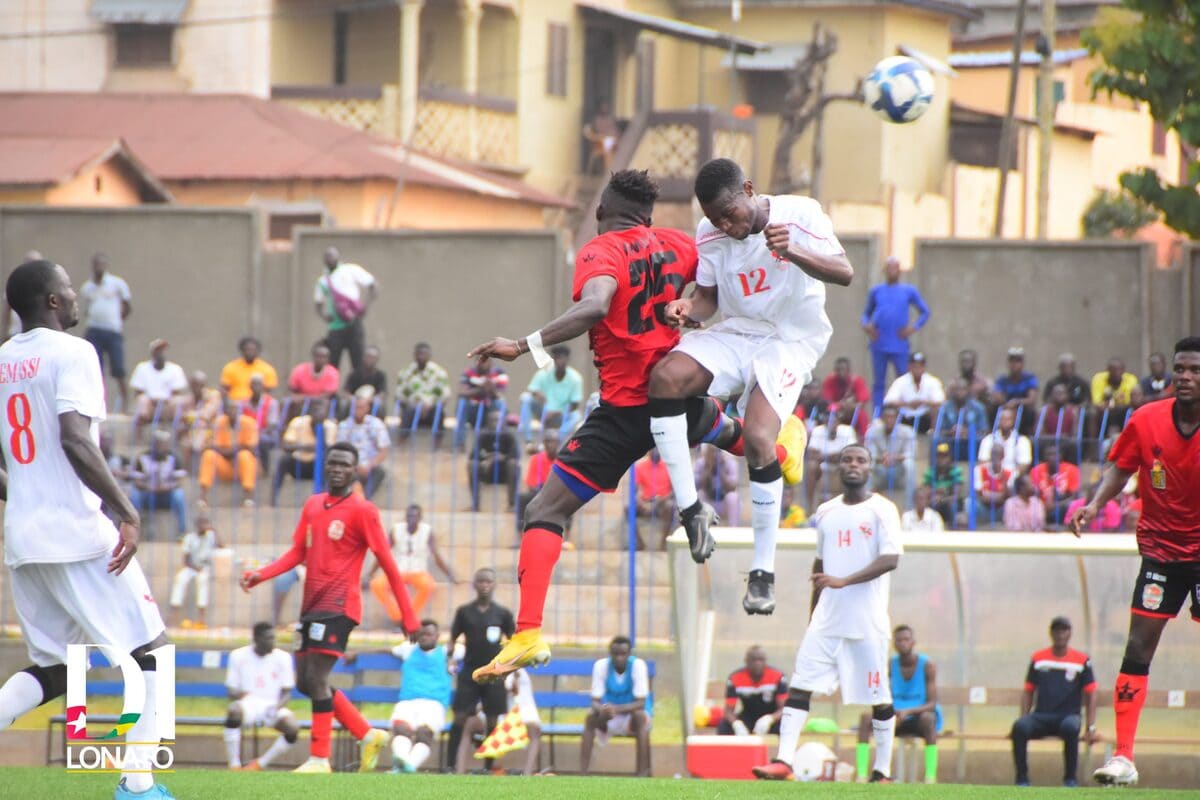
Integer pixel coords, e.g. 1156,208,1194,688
1012,616,1099,786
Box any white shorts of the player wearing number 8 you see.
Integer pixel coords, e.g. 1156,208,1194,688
8,554,166,667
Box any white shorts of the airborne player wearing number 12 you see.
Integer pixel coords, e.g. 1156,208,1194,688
674,324,821,422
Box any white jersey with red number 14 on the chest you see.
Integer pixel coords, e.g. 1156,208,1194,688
809,494,904,639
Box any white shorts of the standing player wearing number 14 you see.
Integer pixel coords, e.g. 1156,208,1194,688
788,633,892,705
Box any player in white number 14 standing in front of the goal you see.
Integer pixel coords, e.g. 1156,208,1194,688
754,445,904,783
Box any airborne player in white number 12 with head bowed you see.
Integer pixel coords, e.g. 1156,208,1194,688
649,158,854,614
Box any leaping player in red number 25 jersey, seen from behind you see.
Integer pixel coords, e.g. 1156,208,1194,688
470,169,740,682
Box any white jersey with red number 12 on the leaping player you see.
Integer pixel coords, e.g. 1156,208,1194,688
696,194,846,345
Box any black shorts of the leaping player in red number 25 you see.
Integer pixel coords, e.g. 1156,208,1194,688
554,397,720,500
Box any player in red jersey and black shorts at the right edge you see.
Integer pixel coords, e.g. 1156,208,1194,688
1070,336,1200,786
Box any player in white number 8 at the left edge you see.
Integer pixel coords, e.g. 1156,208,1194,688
0,260,174,800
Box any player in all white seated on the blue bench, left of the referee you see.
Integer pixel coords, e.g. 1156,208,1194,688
224,622,300,771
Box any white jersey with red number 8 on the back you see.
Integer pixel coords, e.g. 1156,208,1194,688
0,327,116,567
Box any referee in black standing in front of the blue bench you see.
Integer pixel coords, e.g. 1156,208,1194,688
446,567,516,768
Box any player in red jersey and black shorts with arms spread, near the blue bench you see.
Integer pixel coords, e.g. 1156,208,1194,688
240,441,420,772
